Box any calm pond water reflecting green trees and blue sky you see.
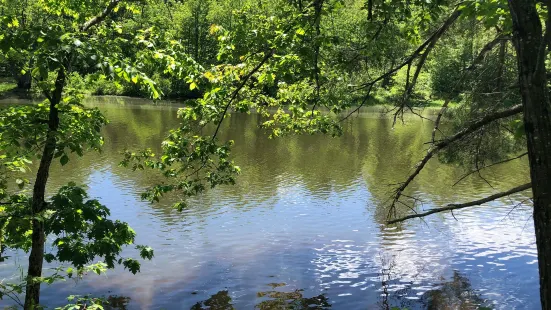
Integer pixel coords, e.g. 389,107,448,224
0,98,539,309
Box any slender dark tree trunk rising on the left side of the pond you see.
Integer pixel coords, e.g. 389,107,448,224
24,69,65,310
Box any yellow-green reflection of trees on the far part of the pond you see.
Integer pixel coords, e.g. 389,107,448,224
52,98,526,228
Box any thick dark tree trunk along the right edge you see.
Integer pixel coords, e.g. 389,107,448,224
509,0,551,310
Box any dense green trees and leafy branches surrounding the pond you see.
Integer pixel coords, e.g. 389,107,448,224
0,0,551,309
